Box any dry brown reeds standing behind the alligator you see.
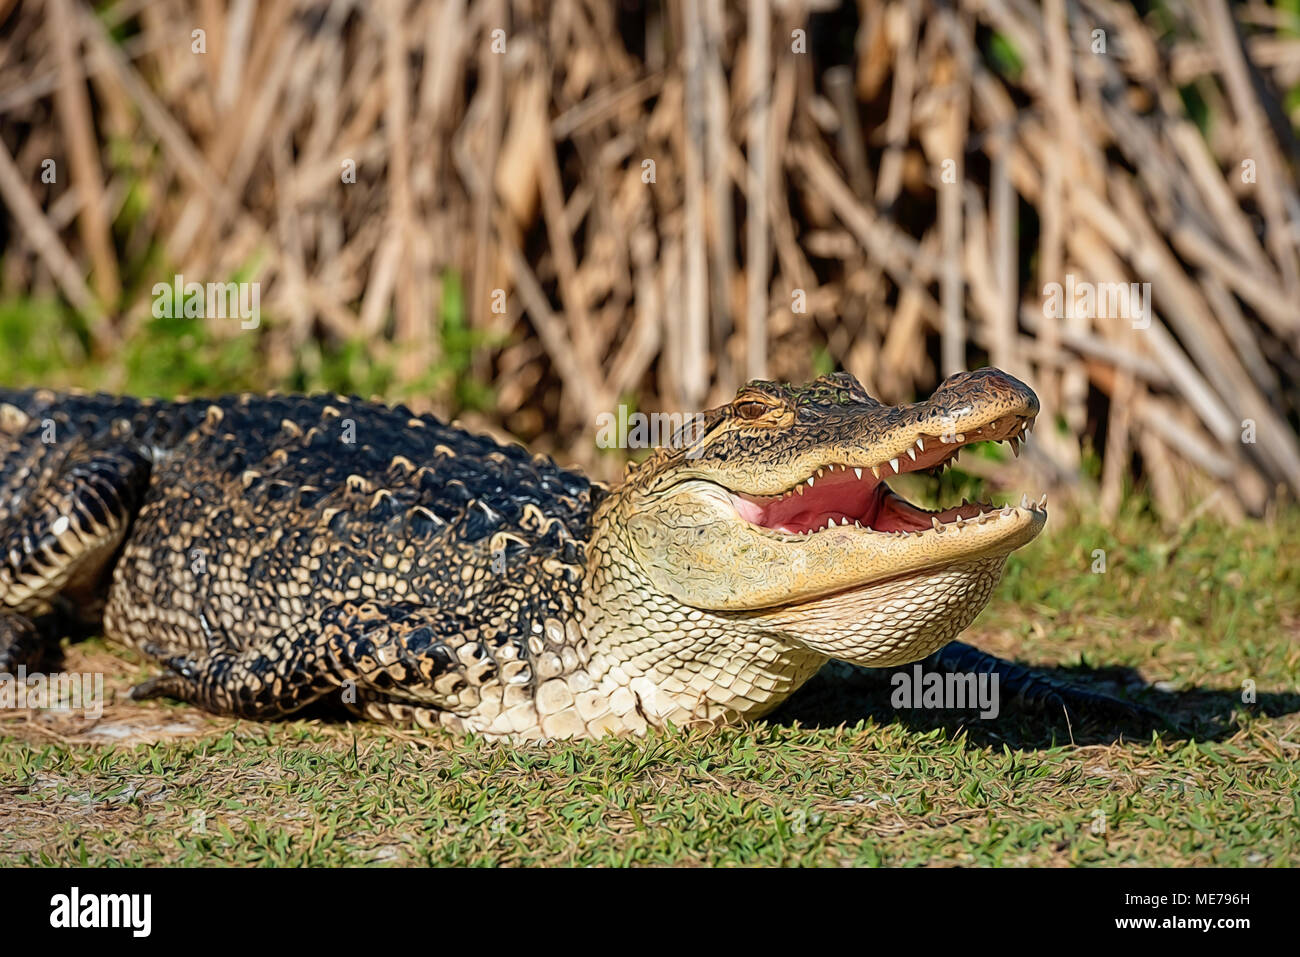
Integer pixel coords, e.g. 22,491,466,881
0,0,1300,524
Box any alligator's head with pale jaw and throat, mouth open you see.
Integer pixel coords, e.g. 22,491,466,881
588,369,1047,714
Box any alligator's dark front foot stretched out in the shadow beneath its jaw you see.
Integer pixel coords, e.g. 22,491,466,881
926,641,1171,726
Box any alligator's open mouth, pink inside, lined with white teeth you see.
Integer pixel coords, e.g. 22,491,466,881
731,415,1047,536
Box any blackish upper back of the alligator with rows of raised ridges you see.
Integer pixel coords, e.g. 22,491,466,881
0,389,603,541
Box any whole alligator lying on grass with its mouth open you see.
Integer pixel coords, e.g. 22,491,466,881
0,368,1138,740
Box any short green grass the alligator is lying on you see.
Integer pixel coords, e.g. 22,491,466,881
0,511,1300,866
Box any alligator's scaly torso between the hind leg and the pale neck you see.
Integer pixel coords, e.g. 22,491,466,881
0,390,605,710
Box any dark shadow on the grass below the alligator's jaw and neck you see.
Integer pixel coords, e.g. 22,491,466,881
766,662,1300,750
